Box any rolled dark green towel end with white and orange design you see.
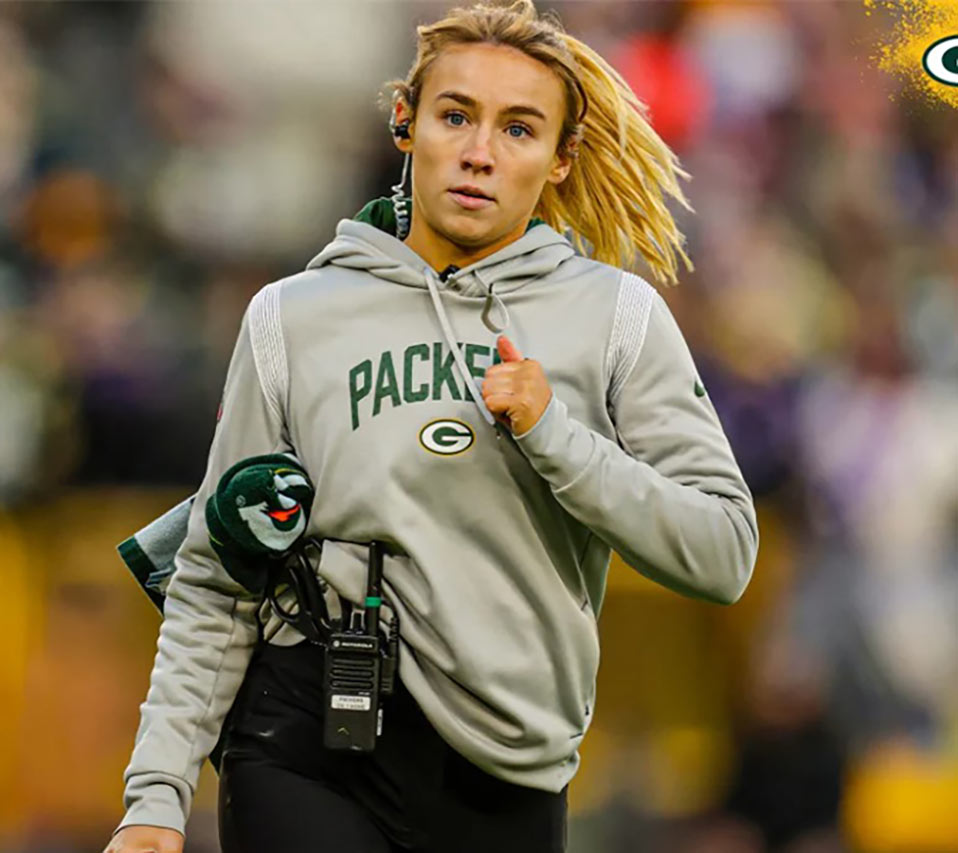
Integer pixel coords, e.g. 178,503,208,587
206,454,315,591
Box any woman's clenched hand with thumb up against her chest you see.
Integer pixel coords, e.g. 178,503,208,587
482,335,552,435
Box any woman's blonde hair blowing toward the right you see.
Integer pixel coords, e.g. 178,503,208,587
386,0,694,284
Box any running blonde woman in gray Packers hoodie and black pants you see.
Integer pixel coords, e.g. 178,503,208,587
107,0,758,853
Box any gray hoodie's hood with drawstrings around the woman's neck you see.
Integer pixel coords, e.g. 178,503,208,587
306,199,575,425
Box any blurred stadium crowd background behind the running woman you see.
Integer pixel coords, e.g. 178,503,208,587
0,0,958,853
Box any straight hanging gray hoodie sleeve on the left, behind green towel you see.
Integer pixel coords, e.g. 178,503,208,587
117,288,290,832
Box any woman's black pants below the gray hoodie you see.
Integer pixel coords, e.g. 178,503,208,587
219,642,566,853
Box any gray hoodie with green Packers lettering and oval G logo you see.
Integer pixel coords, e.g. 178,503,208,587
121,213,758,831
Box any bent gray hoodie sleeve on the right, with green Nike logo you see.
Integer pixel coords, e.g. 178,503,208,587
516,291,758,604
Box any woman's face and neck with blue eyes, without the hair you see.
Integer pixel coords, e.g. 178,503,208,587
397,44,570,253
